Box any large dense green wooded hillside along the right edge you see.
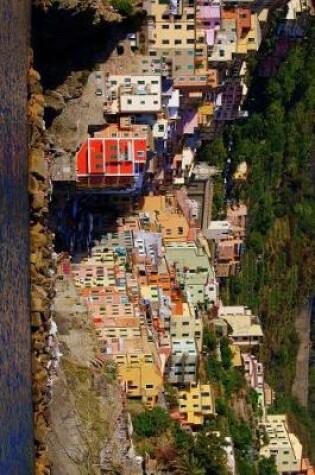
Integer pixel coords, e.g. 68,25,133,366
222,19,315,462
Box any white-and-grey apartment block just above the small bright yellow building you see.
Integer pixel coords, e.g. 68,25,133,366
166,338,198,385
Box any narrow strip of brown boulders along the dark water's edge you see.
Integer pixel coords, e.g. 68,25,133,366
28,51,55,475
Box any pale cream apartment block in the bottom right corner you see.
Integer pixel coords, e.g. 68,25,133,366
259,414,302,475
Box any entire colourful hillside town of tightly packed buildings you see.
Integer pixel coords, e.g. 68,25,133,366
47,0,315,475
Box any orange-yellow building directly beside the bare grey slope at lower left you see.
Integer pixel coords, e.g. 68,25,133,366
106,337,163,407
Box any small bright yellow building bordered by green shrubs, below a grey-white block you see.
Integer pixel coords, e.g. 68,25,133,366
178,383,215,426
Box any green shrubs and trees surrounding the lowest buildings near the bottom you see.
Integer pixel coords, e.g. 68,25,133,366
131,329,276,475
